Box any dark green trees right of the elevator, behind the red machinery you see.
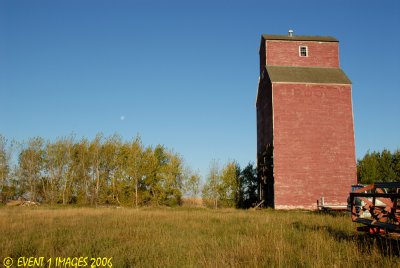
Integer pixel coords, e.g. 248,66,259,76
357,149,400,184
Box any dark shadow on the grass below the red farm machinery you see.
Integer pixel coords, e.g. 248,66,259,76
292,222,400,257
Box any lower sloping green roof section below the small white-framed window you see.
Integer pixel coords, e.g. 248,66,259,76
266,66,351,84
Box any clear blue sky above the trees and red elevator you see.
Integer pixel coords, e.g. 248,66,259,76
0,0,400,179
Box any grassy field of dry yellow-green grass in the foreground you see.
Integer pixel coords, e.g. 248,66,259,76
0,207,400,267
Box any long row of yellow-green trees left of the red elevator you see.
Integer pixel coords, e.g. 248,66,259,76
0,134,256,208
